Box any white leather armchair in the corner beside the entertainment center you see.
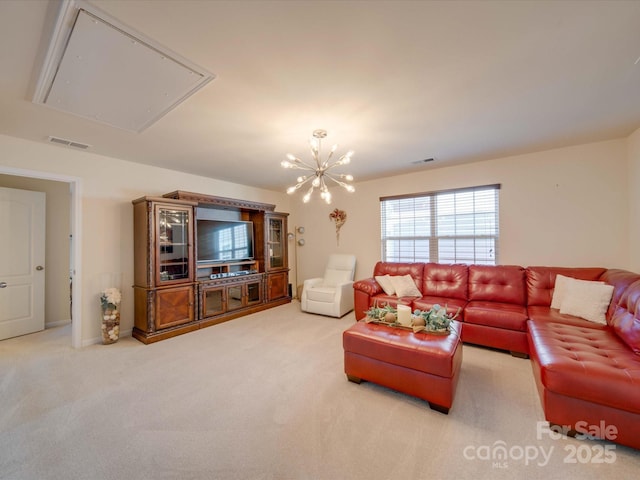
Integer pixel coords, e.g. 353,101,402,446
300,253,356,318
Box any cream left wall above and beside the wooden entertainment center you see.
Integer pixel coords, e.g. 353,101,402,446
0,135,290,344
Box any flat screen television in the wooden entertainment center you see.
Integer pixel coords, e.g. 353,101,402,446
196,219,254,263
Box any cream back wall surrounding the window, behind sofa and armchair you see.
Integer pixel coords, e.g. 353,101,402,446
292,139,640,283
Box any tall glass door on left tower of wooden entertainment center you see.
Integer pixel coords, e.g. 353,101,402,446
156,205,192,284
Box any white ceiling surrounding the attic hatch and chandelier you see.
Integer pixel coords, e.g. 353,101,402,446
0,0,640,190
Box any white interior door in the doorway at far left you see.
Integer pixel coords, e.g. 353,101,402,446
0,188,45,340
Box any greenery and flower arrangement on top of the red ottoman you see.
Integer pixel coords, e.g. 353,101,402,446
365,304,460,333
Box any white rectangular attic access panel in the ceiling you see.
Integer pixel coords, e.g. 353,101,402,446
41,9,214,132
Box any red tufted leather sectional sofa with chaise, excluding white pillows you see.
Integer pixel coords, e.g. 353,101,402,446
353,262,640,449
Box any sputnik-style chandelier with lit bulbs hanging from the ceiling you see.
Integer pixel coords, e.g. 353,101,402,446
280,130,356,203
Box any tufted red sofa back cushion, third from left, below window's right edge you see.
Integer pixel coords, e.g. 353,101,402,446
469,265,526,305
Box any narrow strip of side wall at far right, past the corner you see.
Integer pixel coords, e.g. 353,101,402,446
627,128,640,272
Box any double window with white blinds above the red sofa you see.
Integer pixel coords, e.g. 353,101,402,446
380,185,500,265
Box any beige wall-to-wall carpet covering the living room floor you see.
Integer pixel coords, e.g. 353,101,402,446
0,302,640,480
